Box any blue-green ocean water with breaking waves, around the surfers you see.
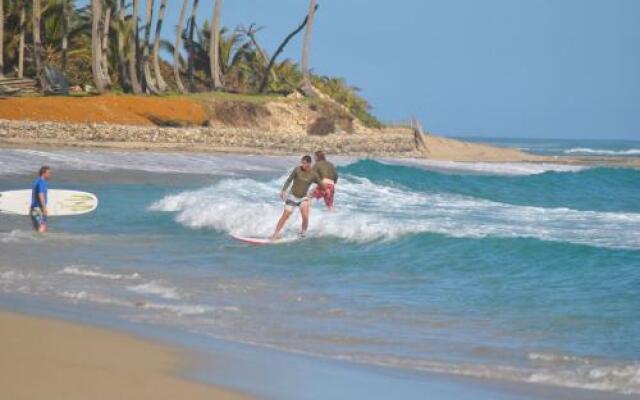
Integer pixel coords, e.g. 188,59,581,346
0,141,640,395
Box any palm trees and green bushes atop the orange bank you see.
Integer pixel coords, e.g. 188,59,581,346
0,0,381,127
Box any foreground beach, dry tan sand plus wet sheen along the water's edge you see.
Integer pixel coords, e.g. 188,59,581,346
0,299,632,400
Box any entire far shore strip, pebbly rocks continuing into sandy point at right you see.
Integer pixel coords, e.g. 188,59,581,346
0,120,640,168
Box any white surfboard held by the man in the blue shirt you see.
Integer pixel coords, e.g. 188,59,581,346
0,189,98,217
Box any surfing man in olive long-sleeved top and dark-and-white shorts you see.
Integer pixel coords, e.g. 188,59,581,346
271,156,322,239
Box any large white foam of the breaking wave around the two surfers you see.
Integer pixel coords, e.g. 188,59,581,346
150,177,640,249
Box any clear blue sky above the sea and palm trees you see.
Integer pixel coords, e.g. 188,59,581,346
155,0,640,140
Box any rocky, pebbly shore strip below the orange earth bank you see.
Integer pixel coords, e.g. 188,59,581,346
0,120,426,158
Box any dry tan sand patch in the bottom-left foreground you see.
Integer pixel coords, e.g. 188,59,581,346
0,312,249,400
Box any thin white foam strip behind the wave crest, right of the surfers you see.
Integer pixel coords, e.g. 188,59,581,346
383,159,588,176
